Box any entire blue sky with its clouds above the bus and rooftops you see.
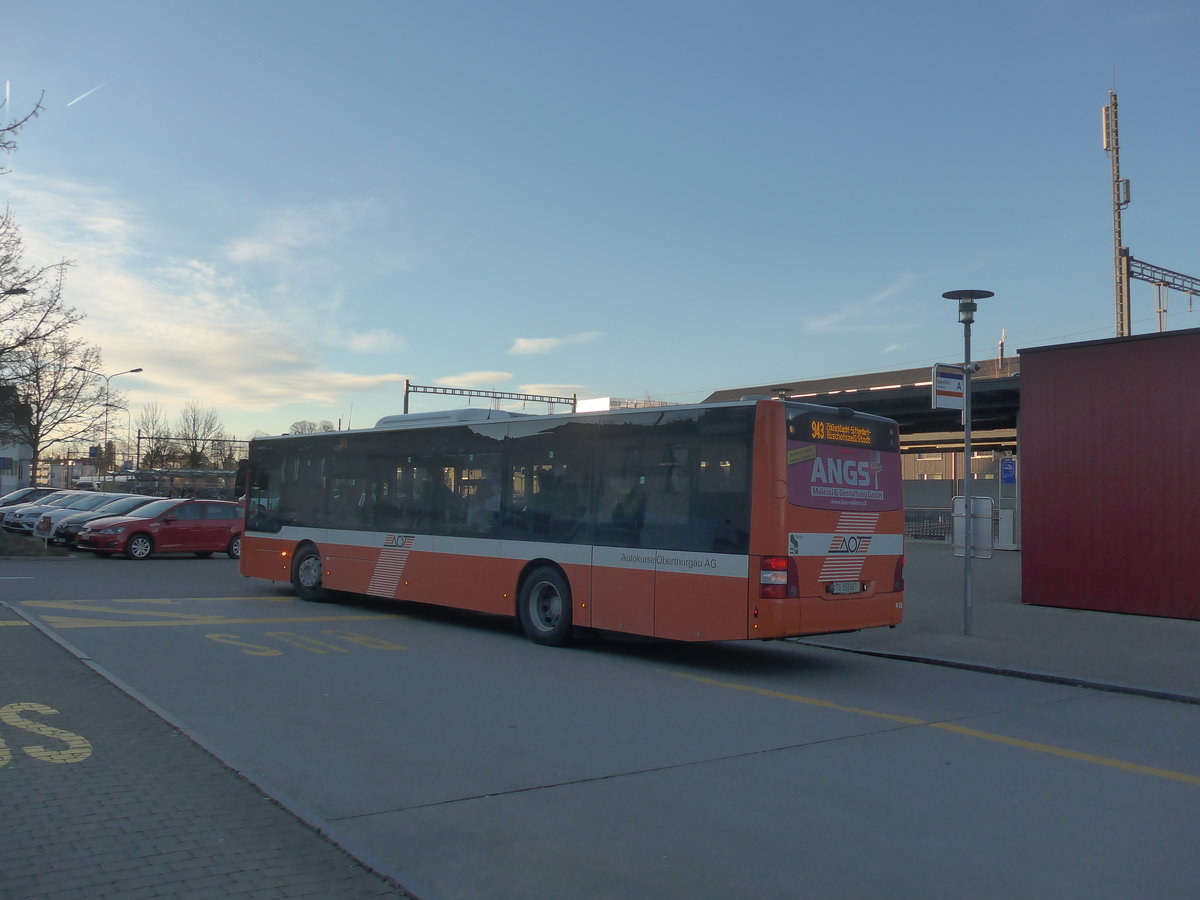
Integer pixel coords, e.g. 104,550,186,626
0,0,1200,437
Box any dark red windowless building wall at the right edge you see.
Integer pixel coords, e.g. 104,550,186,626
1019,329,1200,619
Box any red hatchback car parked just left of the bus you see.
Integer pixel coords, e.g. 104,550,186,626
76,499,242,559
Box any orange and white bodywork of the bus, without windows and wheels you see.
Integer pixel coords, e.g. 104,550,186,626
241,401,904,641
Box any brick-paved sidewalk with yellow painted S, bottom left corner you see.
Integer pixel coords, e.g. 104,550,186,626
0,604,408,900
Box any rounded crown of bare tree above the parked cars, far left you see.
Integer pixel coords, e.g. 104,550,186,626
0,332,109,480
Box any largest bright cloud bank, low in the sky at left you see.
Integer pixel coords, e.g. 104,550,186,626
5,175,404,434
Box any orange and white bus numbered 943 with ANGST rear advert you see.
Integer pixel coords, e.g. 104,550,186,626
241,400,904,644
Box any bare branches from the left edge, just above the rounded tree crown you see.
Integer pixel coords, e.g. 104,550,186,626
0,208,84,362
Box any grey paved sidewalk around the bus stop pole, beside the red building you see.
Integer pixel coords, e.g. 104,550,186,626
804,541,1200,703
